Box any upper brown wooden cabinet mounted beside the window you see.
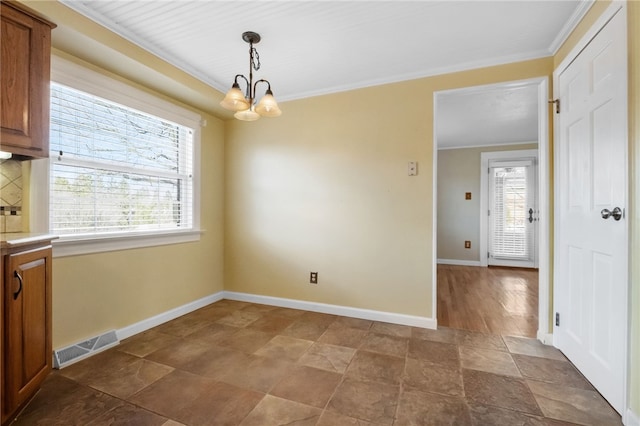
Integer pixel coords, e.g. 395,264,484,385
0,1,55,158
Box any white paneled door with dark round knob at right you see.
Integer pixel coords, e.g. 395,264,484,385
553,6,628,412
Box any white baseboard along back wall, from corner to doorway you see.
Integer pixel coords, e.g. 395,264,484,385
224,291,438,329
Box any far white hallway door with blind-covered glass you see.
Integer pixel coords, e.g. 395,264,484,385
487,158,538,268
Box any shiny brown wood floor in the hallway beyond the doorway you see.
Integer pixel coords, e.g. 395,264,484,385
438,265,538,337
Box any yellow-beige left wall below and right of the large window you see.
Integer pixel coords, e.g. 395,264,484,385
53,107,224,348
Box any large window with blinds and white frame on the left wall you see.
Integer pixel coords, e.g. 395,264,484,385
49,56,199,254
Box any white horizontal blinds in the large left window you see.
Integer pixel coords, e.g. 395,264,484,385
50,83,193,236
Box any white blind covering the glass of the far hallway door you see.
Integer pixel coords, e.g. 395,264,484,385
490,163,533,260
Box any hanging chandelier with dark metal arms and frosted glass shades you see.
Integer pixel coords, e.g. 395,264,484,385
220,31,282,121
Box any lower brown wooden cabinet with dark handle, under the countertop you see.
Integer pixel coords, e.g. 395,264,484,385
3,246,52,417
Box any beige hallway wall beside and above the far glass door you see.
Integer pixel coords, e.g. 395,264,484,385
437,143,538,262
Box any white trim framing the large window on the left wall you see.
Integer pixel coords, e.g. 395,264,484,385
30,55,203,257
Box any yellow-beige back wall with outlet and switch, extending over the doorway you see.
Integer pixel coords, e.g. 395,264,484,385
225,58,552,318
